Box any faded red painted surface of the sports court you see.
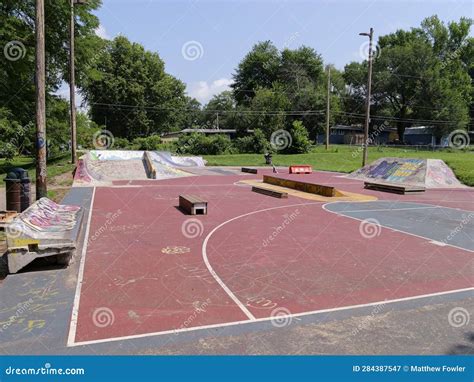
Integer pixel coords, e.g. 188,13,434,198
75,172,474,342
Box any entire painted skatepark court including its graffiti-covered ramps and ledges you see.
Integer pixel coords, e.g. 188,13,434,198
0,150,474,354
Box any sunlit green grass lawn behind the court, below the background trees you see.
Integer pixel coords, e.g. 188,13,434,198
204,145,474,186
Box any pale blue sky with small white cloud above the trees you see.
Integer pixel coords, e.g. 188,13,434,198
91,0,473,103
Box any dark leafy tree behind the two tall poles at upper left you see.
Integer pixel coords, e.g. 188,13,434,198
0,0,101,126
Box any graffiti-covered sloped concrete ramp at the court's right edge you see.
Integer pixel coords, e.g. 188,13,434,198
346,158,466,188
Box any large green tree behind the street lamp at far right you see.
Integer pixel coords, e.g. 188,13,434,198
344,16,473,140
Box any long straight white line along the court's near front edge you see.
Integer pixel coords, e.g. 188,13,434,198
68,288,474,347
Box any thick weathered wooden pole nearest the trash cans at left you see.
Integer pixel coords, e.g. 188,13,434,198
35,0,48,199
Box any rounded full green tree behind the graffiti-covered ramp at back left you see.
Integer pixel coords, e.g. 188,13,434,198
84,36,189,140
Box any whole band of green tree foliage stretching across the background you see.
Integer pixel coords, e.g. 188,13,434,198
0,4,474,157
